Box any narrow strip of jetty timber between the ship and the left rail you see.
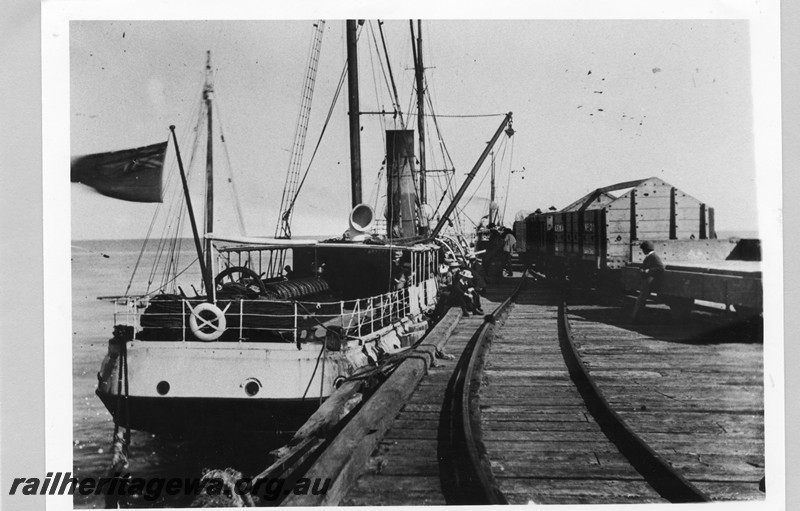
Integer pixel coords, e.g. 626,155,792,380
285,278,519,505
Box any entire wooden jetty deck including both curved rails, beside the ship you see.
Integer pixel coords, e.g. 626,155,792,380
242,266,764,505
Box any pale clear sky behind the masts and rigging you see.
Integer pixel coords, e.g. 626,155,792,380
69,20,758,239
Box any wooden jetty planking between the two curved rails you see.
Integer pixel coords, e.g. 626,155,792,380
480,286,665,504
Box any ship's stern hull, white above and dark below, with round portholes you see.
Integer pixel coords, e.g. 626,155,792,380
96,312,427,437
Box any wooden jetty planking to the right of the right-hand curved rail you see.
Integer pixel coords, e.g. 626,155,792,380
570,305,764,500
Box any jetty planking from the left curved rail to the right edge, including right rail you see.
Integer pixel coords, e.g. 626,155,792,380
481,280,764,504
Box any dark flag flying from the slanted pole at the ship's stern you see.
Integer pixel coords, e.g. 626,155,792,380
70,142,167,202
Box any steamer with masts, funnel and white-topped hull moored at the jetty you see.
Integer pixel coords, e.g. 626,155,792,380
86,20,513,435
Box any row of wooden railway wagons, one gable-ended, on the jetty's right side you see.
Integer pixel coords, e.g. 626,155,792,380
514,177,762,316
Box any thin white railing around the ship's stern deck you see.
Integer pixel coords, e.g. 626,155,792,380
114,288,412,344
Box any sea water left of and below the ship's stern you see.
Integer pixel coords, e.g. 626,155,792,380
72,240,290,508
